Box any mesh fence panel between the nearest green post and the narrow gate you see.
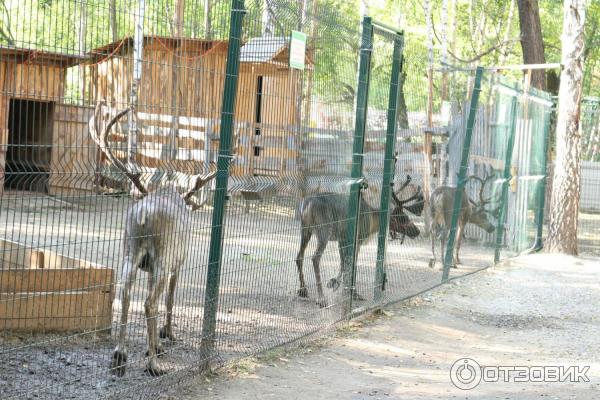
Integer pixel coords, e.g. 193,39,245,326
206,1,366,359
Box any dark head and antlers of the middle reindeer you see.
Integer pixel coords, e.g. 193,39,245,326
390,175,424,239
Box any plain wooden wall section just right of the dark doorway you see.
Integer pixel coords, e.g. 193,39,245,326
48,105,96,195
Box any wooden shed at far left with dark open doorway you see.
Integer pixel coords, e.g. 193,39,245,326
0,47,82,194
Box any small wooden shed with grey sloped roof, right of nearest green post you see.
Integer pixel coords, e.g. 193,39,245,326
234,37,311,176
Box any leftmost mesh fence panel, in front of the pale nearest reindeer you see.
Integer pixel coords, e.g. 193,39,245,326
0,0,231,399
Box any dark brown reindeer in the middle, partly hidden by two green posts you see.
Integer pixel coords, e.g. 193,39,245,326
296,176,423,307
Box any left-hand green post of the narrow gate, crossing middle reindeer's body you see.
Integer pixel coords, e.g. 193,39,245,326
344,17,373,315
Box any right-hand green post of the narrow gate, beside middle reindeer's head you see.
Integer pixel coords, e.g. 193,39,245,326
373,35,404,301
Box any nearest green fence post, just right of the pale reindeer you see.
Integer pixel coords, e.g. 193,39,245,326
201,0,246,363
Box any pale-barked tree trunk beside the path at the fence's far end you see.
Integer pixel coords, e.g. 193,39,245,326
548,0,586,255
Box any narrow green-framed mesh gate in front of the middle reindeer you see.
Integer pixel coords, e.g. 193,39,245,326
345,17,404,312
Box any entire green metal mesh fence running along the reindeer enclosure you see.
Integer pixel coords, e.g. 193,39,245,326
0,0,550,399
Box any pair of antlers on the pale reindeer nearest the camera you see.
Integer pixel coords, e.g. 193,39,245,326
88,100,217,210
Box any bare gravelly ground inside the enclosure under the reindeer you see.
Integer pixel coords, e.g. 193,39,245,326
0,193,493,400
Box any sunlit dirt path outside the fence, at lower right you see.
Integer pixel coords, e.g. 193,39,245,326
169,255,600,399
